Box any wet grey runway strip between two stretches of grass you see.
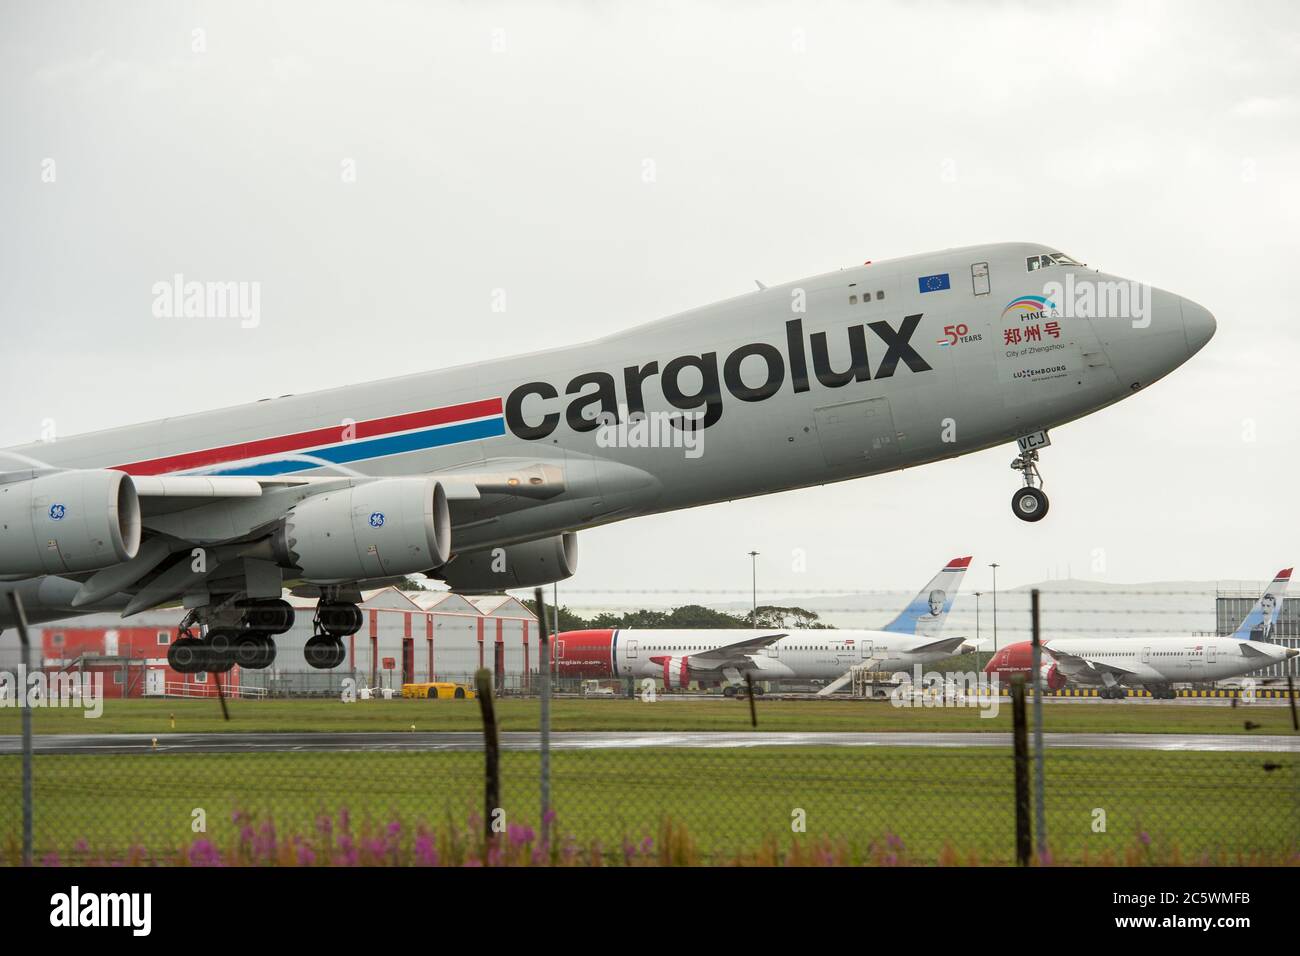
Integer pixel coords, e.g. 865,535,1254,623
0,731,1300,754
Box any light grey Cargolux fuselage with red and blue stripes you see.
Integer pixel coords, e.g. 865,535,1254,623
0,243,1214,629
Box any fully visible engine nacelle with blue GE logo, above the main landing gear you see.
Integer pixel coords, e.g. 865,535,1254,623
273,477,451,584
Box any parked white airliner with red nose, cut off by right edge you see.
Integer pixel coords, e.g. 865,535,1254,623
984,567,1300,700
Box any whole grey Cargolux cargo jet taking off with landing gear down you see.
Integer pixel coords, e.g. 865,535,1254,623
0,243,1216,672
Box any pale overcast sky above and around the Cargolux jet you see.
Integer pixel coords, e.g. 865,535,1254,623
0,1,1300,593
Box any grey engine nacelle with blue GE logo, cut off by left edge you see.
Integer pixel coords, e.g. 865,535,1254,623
0,470,140,576
